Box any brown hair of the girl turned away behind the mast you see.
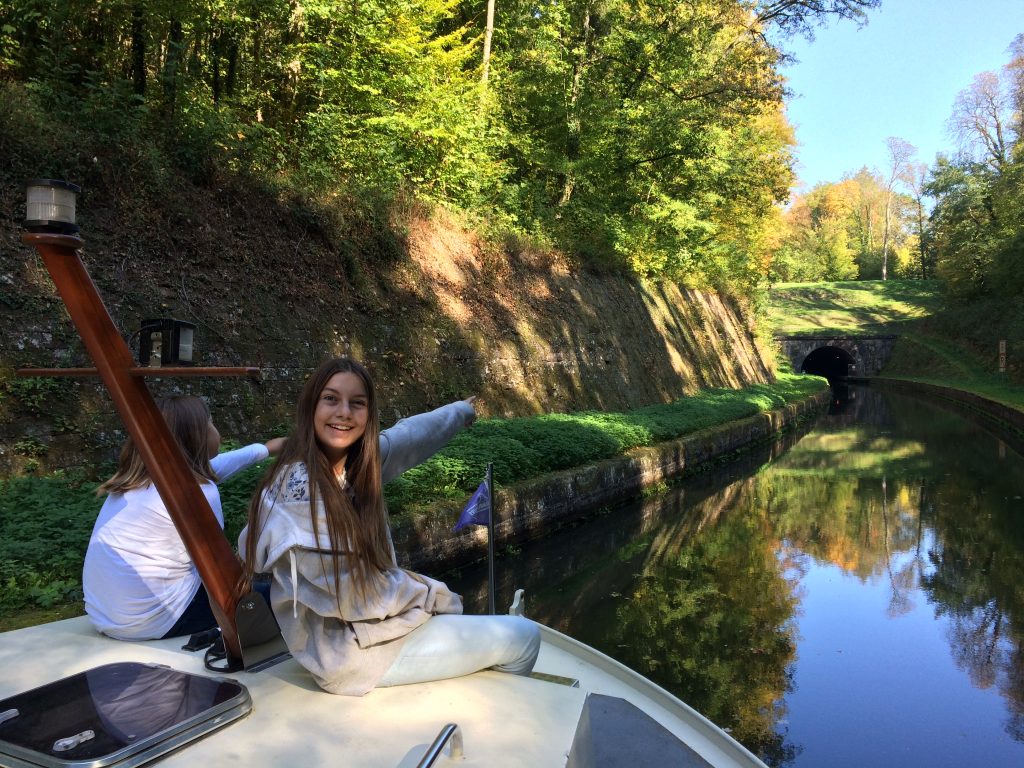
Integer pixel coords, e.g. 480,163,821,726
96,394,217,496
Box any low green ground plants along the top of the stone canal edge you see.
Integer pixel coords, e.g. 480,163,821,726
0,376,824,612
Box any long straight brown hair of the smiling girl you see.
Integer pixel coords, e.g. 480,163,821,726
243,357,394,599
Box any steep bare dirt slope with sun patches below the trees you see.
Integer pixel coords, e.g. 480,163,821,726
0,167,771,476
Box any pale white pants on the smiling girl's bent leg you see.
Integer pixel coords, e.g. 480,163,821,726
377,613,541,688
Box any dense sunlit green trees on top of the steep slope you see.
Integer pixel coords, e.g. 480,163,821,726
0,0,879,291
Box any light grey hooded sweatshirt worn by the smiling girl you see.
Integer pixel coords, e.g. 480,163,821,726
239,401,473,695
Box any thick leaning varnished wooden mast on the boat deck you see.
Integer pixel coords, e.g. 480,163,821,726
22,232,242,658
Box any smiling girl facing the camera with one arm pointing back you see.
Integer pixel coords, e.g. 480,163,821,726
239,358,540,695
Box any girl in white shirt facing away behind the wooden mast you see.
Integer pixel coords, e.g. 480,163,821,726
82,395,284,640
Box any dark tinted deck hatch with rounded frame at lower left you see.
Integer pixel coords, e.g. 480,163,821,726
0,663,252,768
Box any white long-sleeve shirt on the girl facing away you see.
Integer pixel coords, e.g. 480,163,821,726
82,443,268,640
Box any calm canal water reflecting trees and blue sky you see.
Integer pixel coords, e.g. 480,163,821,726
446,388,1024,768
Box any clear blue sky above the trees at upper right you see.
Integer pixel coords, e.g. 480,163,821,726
783,0,1024,191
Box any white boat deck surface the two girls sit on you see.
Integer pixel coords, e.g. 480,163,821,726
0,616,763,768
